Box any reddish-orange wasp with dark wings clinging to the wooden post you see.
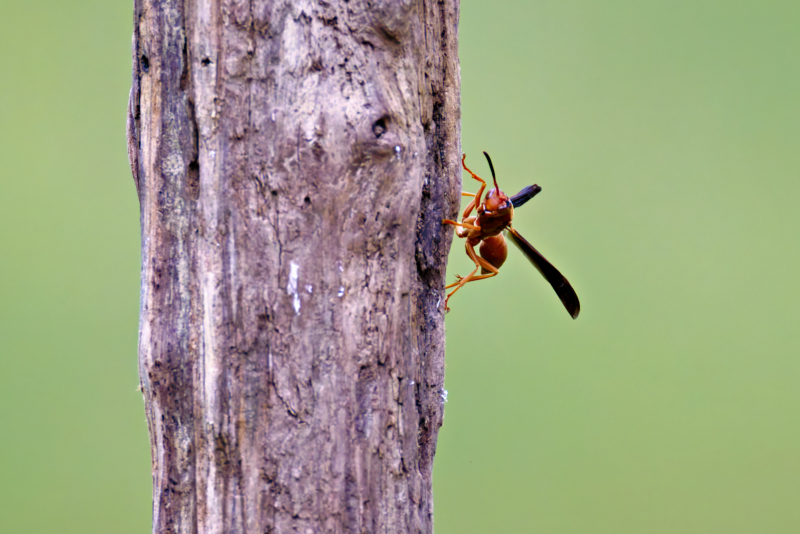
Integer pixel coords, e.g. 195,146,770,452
442,152,581,319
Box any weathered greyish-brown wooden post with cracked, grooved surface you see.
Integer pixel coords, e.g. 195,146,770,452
128,0,460,534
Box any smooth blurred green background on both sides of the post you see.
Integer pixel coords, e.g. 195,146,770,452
0,0,800,534
